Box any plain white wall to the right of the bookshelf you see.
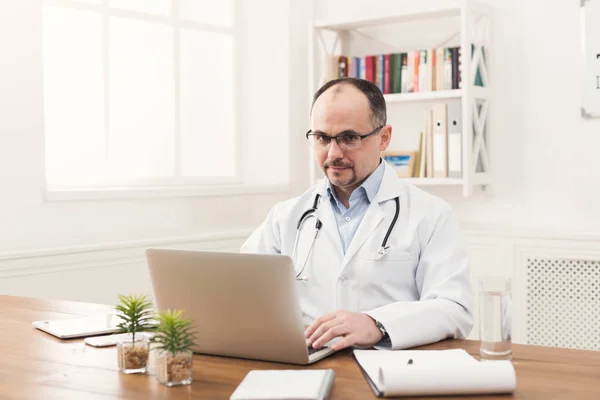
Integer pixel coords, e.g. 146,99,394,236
315,0,600,233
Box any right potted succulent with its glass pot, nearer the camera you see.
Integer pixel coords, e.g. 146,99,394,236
151,310,194,386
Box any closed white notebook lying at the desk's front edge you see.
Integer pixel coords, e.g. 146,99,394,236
230,369,335,400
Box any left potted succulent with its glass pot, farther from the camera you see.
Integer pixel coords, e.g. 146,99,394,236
115,295,155,374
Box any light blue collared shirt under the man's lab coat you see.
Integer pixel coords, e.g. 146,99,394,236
327,162,385,254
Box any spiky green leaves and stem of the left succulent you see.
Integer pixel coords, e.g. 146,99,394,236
115,295,156,346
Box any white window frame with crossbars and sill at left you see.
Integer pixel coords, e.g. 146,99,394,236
42,0,246,197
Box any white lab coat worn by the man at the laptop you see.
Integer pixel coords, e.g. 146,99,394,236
241,163,473,349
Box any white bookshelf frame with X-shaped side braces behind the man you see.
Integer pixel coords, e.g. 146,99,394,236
309,0,493,197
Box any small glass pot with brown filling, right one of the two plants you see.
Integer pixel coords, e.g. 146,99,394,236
156,350,194,386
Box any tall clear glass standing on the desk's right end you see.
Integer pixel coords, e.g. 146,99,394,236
479,277,512,361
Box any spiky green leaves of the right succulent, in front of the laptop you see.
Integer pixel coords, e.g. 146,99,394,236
152,309,194,357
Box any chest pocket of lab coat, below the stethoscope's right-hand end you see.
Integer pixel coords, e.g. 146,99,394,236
358,249,419,311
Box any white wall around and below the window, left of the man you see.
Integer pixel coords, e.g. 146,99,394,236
0,0,309,300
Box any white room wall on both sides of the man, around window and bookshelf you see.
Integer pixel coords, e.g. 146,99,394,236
0,0,600,301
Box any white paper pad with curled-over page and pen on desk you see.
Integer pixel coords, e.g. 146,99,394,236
354,349,516,397
